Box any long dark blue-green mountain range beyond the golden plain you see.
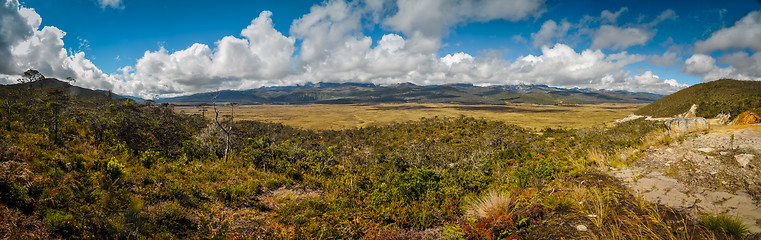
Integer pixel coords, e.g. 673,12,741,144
156,83,663,105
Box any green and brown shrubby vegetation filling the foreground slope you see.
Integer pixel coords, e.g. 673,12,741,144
0,83,748,239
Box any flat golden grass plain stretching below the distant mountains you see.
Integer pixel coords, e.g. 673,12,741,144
175,103,645,130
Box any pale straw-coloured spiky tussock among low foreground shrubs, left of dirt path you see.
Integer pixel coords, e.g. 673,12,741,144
466,190,515,219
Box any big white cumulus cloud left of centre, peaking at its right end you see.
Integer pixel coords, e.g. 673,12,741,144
122,11,295,97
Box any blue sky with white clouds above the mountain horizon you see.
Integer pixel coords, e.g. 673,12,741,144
0,0,761,99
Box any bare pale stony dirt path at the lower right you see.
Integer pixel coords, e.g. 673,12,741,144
610,126,761,233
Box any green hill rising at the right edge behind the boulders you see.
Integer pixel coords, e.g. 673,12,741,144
634,79,761,117
